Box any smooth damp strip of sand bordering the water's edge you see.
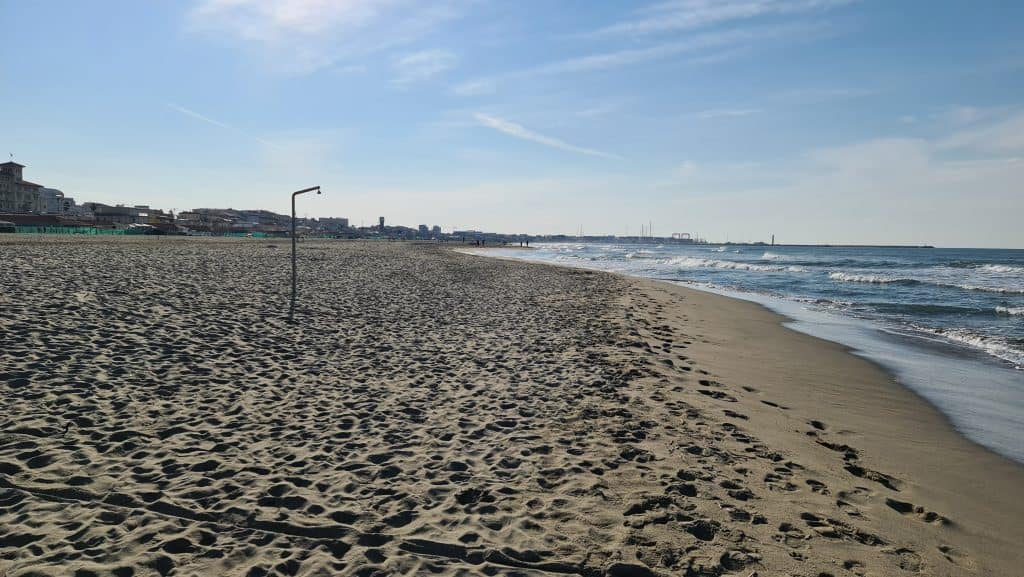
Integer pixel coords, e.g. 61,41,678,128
465,246,1024,575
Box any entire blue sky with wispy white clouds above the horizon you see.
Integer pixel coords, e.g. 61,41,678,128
0,0,1024,247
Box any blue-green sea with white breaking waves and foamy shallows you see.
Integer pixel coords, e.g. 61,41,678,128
488,242,1024,463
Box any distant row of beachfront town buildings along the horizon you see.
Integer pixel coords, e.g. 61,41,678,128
0,161,706,244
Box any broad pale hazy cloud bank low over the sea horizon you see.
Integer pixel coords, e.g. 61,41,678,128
664,114,1024,247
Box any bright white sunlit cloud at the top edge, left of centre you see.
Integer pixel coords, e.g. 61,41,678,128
187,0,469,74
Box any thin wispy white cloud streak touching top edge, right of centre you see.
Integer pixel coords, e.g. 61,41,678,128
597,0,853,36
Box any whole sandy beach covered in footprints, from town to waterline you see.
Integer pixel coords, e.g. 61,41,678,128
0,236,1024,577
